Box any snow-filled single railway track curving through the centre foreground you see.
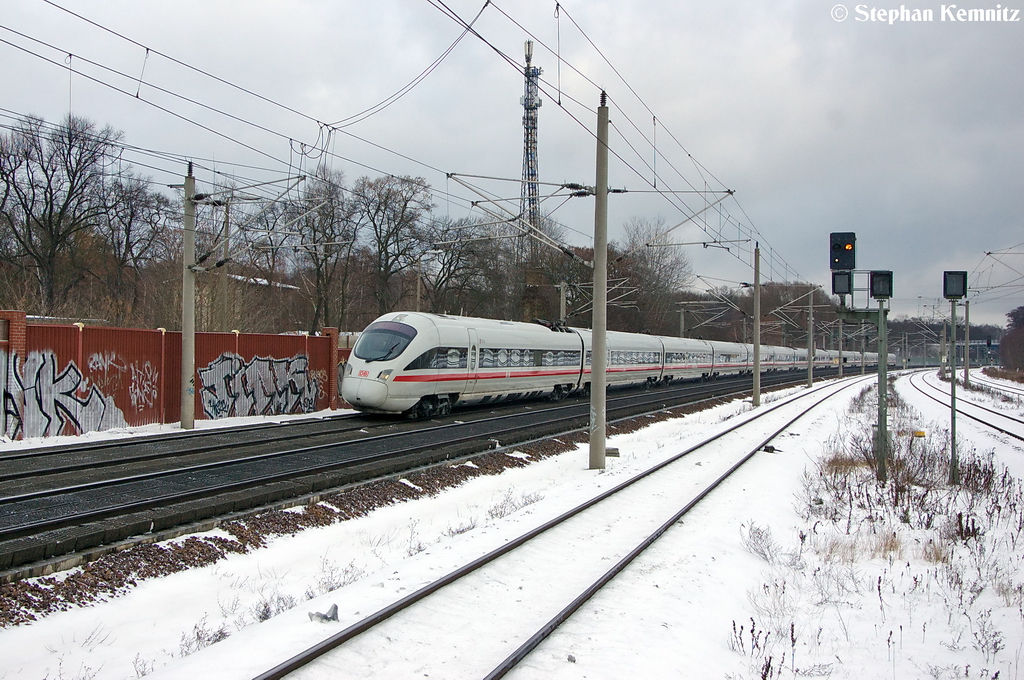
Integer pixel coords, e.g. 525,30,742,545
241,378,869,680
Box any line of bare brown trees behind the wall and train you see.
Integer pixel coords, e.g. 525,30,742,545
0,116,1015,366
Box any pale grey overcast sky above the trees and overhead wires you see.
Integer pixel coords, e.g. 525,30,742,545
0,0,1024,326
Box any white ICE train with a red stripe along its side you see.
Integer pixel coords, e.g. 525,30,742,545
341,312,878,417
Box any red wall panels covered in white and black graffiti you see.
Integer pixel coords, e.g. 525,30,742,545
0,311,338,438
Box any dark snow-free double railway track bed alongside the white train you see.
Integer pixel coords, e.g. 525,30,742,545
0,373,831,580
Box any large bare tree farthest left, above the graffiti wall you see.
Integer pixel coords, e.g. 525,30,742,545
0,116,122,314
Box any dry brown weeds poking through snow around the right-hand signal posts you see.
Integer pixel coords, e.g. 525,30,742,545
729,388,1024,678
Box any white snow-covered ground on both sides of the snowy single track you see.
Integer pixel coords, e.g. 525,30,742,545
0,378,1024,679
